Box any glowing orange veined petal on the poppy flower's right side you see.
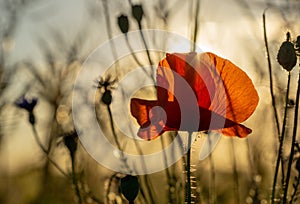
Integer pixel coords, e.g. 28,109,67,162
202,53,259,123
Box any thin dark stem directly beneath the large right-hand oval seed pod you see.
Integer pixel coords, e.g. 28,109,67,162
272,72,291,204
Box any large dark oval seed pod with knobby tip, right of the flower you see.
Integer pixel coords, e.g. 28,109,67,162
277,32,297,71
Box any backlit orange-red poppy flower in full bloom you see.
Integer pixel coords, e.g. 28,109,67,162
130,52,259,140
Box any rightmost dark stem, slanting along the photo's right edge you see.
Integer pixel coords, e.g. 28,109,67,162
283,69,300,204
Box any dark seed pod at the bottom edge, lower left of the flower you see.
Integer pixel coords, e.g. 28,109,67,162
120,175,140,203
